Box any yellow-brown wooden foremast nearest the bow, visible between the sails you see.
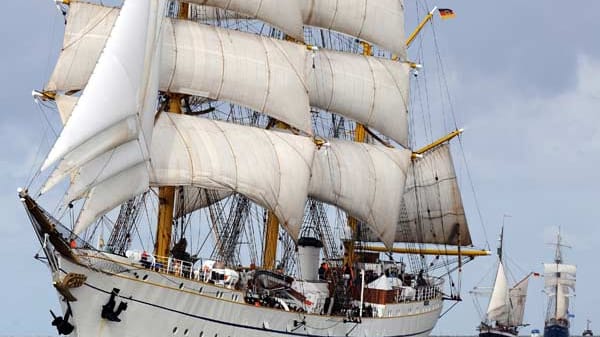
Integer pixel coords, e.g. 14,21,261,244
154,2,189,257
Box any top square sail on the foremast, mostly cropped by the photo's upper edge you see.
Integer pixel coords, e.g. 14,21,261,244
188,0,304,41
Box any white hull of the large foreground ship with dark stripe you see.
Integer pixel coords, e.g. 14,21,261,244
51,254,442,337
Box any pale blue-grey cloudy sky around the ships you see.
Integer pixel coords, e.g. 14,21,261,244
0,0,600,335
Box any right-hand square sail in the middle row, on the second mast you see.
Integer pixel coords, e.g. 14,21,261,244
307,50,410,147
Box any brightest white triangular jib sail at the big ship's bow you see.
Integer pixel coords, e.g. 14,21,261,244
42,0,163,169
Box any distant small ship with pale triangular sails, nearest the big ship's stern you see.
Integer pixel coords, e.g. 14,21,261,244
474,226,533,337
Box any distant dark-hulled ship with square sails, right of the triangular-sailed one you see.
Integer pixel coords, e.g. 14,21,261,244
544,231,577,337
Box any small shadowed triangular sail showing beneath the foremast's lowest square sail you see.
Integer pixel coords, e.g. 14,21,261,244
173,186,233,218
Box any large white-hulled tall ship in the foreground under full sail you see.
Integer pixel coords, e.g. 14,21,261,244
18,0,489,337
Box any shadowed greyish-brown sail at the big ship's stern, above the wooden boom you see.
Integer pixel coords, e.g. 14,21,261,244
363,144,472,246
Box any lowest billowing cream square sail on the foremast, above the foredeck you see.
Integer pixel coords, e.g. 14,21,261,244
150,113,314,238
